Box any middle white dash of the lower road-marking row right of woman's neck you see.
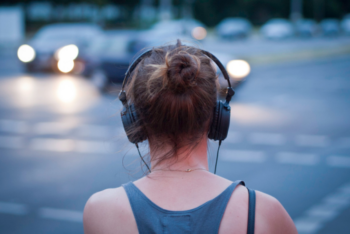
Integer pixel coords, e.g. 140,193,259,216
276,152,320,165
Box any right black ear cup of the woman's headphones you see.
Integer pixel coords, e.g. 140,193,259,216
208,101,231,141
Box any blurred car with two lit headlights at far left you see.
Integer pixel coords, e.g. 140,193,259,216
17,23,103,75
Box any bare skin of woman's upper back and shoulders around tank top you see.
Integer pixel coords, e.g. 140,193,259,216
84,171,297,234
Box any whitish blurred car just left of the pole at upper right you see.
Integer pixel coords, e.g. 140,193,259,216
260,19,294,39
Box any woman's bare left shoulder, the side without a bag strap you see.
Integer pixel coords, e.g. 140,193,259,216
83,187,137,234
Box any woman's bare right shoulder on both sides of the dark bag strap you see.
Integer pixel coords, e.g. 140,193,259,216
220,185,297,234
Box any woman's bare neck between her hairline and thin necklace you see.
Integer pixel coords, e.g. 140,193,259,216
150,136,209,171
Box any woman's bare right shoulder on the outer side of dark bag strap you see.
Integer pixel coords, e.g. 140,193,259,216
255,191,298,234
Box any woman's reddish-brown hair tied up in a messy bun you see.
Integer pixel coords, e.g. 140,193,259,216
127,40,218,166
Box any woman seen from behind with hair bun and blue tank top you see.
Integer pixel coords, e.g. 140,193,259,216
84,41,297,234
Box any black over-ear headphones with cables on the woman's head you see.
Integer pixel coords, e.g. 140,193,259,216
119,46,235,173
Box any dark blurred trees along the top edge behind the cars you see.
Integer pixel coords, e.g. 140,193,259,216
0,0,350,26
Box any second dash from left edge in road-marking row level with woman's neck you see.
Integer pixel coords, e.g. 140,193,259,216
30,138,75,152
